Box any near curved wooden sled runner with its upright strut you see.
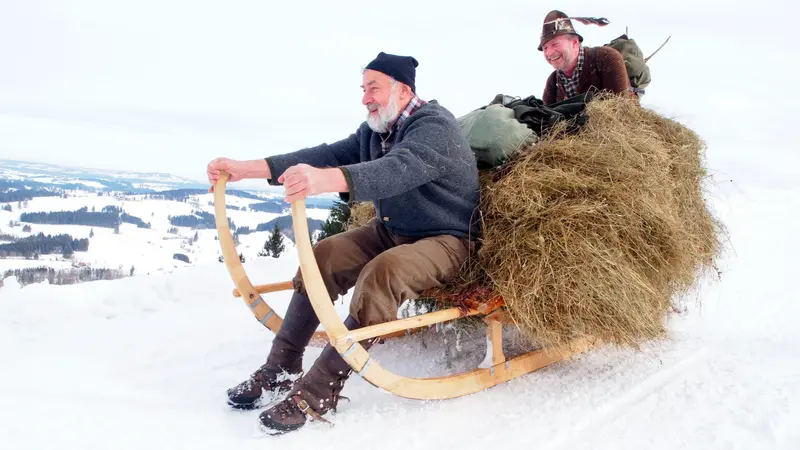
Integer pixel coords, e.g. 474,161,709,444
290,200,590,400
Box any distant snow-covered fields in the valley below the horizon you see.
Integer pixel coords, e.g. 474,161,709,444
0,191,329,275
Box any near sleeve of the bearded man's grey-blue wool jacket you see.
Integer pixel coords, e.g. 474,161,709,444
340,112,461,201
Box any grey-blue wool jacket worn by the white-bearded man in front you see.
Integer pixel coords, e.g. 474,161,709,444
265,100,480,239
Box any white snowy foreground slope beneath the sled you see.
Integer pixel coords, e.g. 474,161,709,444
0,183,800,450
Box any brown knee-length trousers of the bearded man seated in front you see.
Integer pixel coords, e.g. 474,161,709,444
293,218,472,327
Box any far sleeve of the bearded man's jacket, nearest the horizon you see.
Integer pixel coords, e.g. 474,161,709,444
264,129,360,186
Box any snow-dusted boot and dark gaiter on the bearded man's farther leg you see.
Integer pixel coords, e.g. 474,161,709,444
227,292,319,409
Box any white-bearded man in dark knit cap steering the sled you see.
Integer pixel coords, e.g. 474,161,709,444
207,52,479,434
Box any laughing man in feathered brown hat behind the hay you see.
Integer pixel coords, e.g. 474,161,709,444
539,11,635,105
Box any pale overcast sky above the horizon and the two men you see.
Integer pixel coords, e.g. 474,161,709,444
0,0,800,189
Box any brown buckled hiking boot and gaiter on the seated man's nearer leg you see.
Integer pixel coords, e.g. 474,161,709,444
259,317,373,435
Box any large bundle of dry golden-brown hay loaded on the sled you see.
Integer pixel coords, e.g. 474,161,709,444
478,96,724,347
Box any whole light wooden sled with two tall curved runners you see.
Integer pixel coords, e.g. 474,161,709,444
214,172,592,400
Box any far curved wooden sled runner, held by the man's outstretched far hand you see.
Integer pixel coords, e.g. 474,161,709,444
214,171,327,340
